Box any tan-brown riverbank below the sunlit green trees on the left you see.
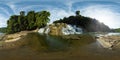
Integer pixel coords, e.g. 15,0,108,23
0,30,36,50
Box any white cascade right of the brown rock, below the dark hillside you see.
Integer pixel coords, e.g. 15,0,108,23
62,25,82,35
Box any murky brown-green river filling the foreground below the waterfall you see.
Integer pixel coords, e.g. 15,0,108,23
0,33,120,60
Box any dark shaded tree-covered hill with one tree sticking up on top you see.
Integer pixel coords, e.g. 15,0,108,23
54,11,110,32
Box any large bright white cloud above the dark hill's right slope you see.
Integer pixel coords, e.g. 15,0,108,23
81,5,120,28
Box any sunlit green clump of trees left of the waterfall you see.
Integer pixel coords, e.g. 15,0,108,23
7,11,50,33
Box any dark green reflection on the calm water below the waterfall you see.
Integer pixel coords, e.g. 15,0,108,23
26,33,95,51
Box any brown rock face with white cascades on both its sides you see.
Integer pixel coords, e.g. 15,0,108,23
38,23,82,35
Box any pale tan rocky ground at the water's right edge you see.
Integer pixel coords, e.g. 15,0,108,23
97,35,120,48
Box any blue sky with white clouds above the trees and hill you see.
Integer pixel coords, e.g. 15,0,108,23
0,0,120,28
